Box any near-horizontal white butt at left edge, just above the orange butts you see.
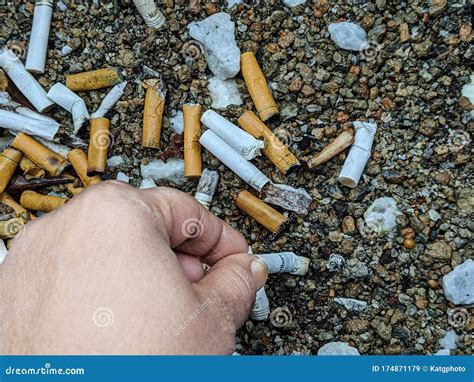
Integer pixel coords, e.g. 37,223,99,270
0,108,61,140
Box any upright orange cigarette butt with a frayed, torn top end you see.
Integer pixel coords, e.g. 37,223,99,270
142,79,165,149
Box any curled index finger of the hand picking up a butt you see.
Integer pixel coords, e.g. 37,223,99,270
141,187,248,265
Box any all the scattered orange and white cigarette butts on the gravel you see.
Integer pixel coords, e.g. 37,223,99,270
0,0,377,320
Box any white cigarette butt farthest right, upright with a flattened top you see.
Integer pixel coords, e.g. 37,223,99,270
338,122,377,188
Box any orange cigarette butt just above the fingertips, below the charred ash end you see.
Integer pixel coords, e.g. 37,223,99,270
235,191,286,233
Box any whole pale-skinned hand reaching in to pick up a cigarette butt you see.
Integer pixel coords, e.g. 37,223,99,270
0,182,267,354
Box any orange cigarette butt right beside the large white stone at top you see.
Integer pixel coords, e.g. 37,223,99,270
240,52,279,121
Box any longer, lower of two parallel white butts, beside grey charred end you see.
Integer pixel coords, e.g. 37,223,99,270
199,130,270,191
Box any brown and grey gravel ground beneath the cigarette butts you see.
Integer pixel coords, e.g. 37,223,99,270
0,0,474,354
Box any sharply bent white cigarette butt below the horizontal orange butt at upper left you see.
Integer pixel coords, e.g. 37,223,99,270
48,83,90,134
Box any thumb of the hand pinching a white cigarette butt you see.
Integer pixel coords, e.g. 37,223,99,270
195,254,268,328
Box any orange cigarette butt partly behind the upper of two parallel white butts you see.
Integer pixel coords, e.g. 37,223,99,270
238,110,300,174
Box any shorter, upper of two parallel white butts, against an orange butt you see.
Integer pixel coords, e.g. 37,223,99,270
201,110,265,160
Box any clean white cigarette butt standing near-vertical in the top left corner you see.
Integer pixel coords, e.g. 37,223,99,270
25,0,53,73
